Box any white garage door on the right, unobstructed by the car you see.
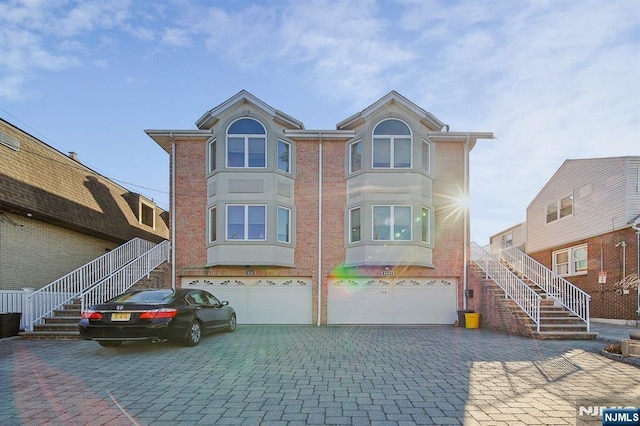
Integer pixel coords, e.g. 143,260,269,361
327,278,458,324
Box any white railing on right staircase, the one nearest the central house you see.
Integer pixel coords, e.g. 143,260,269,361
471,242,542,333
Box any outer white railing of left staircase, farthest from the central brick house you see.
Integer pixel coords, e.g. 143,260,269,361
22,238,164,331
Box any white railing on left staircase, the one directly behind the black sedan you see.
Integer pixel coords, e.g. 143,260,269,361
78,241,169,311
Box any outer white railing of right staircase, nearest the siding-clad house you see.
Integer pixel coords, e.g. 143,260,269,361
500,246,591,332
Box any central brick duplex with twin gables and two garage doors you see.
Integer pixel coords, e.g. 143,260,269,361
146,91,493,324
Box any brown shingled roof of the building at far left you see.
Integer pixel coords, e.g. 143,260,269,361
0,119,169,243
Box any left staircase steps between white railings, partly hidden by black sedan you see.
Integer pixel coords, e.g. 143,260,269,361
19,243,171,340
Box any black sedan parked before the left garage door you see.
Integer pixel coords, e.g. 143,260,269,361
79,289,236,347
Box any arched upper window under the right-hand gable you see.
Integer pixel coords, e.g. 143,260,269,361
373,119,411,169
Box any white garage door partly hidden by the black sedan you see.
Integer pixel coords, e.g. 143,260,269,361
182,277,312,324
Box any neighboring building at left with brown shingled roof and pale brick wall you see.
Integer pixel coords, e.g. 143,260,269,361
0,119,169,290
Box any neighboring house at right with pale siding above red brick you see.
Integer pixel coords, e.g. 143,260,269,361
526,156,640,320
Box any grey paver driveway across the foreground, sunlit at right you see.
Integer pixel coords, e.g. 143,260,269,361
0,326,640,425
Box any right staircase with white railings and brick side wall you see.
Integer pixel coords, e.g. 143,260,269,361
473,246,597,340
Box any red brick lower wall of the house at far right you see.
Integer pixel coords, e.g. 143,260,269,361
528,228,638,320
